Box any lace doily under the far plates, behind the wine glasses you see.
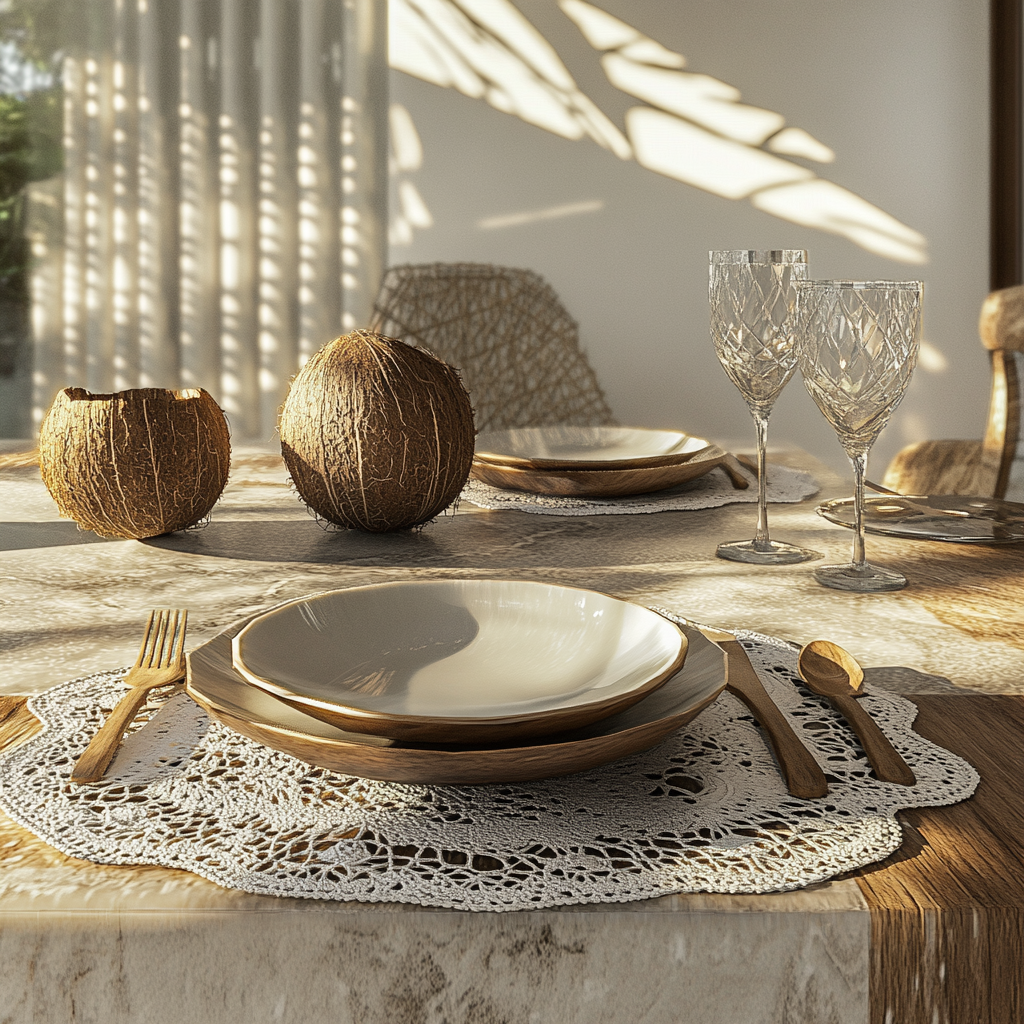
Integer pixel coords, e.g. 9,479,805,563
460,466,818,515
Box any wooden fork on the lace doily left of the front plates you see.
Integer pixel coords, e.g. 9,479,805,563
71,608,188,782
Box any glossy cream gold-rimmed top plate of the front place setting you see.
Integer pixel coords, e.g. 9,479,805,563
232,580,686,742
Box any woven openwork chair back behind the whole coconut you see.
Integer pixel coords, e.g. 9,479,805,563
371,263,614,430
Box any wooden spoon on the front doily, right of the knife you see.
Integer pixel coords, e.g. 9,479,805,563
798,640,918,785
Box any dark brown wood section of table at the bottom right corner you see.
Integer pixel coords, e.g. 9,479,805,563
856,695,1024,1024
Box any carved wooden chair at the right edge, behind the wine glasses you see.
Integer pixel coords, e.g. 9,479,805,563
882,285,1024,498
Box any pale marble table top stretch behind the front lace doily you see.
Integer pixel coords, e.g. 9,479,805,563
0,450,1024,693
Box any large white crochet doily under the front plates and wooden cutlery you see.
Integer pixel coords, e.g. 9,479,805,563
0,633,978,910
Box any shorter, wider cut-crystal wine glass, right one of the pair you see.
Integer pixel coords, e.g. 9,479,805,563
797,281,923,592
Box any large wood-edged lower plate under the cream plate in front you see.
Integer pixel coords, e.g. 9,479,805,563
185,620,727,784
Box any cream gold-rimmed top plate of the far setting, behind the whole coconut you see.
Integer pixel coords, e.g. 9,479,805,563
475,426,710,469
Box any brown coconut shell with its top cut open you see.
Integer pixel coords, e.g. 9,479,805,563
39,388,231,540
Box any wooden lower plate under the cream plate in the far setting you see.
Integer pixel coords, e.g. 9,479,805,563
470,444,746,498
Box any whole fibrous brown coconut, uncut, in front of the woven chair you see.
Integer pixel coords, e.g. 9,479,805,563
280,331,475,532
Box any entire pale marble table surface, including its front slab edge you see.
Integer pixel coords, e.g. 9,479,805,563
0,450,1024,1024
